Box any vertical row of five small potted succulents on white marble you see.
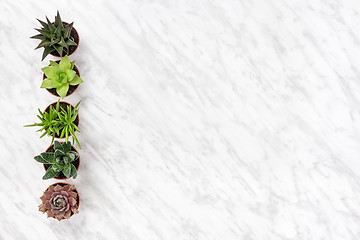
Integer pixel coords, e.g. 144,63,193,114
25,11,83,221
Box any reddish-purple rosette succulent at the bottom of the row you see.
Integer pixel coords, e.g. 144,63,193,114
39,184,79,221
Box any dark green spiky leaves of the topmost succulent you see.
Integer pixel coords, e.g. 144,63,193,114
31,11,77,61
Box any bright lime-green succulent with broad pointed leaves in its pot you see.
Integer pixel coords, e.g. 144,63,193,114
41,55,83,98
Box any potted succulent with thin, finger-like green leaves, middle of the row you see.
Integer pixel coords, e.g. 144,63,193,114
25,99,81,149
